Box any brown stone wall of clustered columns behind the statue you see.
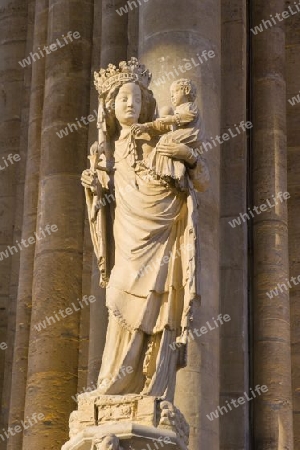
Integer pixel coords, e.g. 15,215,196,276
0,0,300,450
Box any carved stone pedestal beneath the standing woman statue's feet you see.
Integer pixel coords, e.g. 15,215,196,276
62,391,189,450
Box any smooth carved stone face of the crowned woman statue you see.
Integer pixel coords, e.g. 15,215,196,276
115,83,142,126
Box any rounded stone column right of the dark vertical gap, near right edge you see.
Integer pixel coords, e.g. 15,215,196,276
252,0,293,450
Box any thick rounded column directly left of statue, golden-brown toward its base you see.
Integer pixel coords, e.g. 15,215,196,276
23,0,93,450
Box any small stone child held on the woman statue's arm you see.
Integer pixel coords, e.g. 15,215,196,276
132,78,202,190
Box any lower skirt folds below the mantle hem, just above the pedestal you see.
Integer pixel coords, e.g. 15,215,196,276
97,314,177,400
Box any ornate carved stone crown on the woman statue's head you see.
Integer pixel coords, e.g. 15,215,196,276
94,57,152,95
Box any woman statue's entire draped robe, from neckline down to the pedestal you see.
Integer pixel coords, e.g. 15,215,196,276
86,131,209,400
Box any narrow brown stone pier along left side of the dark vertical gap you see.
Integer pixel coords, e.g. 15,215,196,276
220,0,251,450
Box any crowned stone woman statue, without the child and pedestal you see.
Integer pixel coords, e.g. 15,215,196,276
82,58,209,401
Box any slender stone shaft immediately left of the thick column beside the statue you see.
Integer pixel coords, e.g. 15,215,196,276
8,0,49,450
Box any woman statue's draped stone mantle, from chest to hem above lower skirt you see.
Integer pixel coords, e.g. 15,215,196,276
85,135,209,334
